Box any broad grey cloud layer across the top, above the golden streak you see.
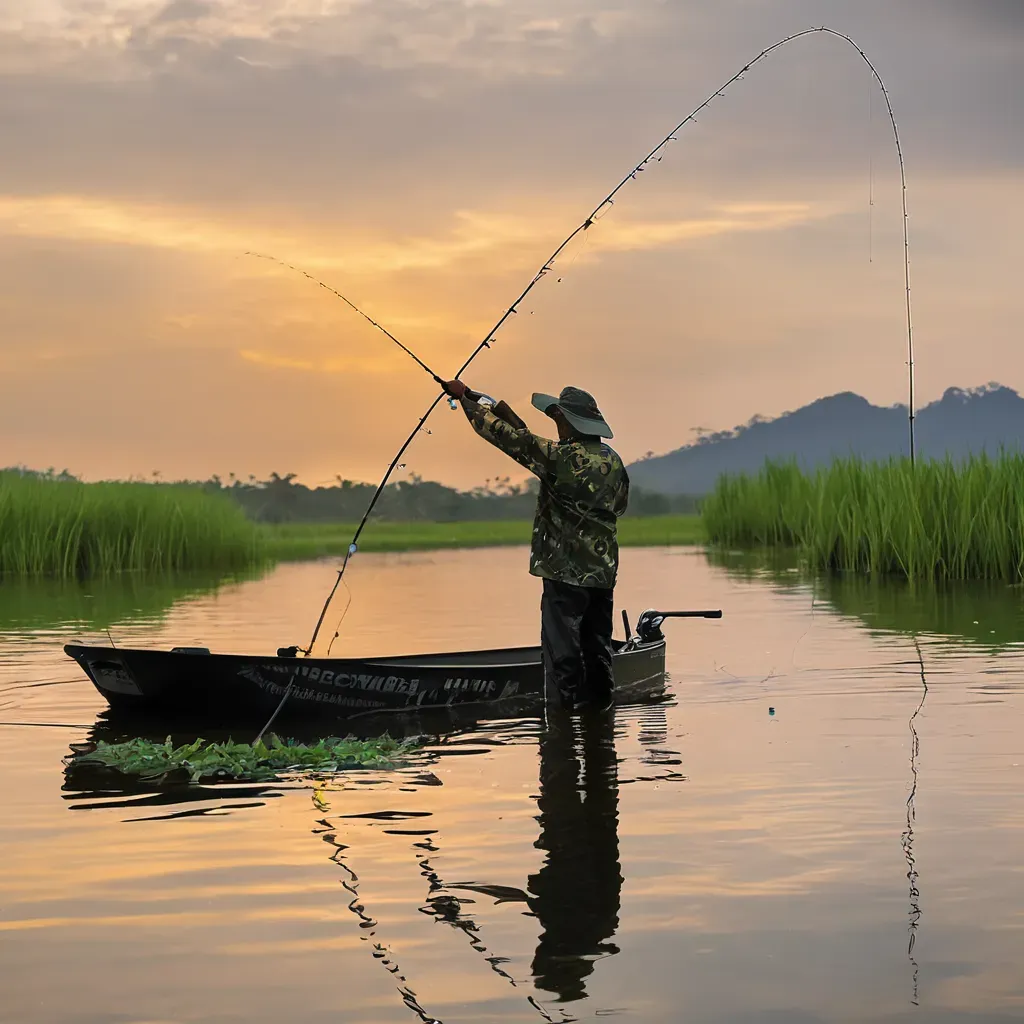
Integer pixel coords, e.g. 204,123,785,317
0,0,1024,216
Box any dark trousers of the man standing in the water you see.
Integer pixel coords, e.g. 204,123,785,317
541,580,614,708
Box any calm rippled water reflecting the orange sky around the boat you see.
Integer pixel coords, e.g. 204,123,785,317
0,549,1024,1024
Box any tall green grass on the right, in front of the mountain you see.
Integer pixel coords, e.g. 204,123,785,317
701,454,1024,582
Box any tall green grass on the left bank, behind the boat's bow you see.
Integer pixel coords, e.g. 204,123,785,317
0,472,262,578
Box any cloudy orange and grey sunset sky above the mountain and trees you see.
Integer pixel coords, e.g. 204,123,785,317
0,0,1024,486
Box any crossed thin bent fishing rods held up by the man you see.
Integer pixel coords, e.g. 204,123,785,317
260,26,914,663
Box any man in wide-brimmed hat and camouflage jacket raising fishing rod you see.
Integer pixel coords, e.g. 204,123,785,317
443,380,630,711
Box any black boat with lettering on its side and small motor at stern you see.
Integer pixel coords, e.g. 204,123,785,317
65,610,722,727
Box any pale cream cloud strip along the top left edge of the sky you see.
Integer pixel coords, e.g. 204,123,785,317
0,0,632,78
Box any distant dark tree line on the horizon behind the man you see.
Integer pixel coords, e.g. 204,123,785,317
2,467,698,523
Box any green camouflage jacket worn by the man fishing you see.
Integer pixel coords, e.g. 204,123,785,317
462,398,630,589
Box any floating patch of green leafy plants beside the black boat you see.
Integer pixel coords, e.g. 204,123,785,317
69,735,416,782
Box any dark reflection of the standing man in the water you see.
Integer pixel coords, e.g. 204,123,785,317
527,714,623,1002
